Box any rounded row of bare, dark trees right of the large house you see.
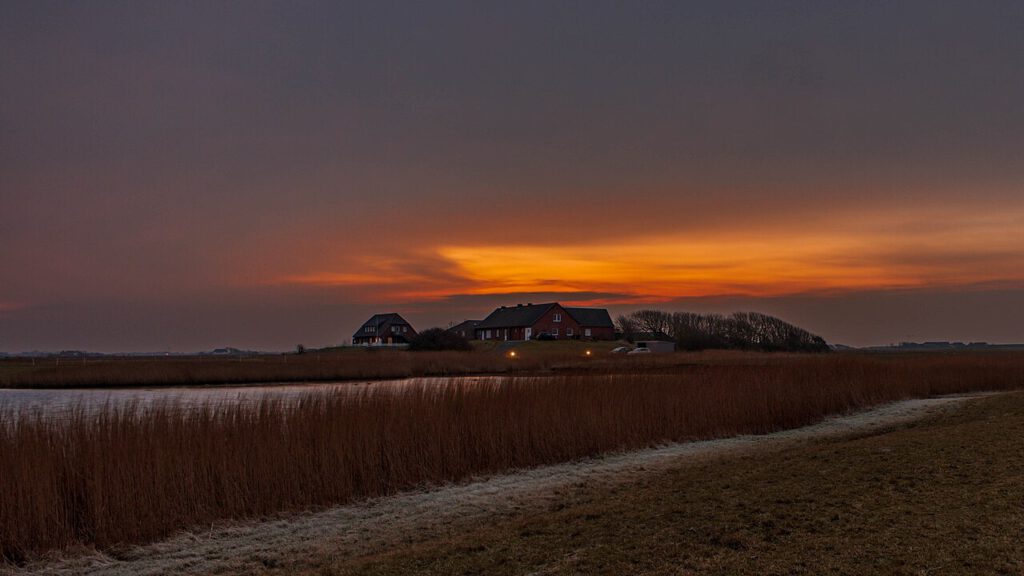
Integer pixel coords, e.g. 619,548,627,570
616,310,829,352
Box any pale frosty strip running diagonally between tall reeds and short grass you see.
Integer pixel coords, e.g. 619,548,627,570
0,396,991,576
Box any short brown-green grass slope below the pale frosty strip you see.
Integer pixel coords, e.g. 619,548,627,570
299,393,1024,576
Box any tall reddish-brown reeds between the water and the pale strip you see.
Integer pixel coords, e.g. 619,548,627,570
0,355,1024,562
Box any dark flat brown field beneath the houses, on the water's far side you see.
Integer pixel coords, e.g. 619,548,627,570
0,341,1024,388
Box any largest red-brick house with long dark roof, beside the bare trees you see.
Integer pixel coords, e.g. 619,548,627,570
474,302,615,340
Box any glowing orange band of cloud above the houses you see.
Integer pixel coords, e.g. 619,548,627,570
272,204,1024,304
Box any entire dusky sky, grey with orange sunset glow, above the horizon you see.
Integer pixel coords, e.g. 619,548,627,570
0,0,1024,352
